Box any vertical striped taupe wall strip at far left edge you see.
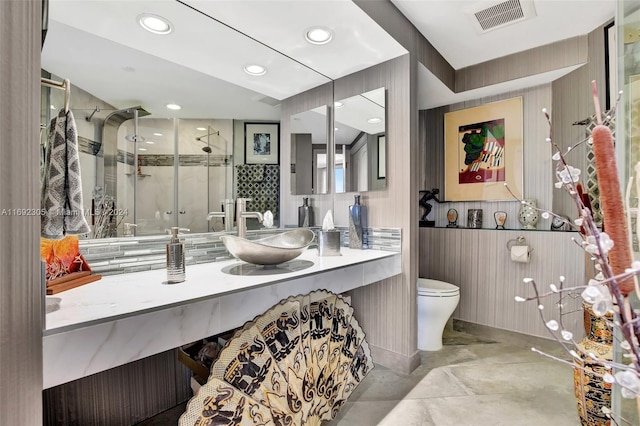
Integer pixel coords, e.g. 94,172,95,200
0,0,43,425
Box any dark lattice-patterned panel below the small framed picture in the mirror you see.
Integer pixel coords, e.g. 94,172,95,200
235,164,280,222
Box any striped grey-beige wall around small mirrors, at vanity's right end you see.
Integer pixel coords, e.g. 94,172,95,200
281,55,420,372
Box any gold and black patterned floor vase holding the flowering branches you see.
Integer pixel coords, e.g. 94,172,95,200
573,304,613,426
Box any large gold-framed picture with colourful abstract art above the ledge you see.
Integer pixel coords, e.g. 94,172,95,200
444,97,523,201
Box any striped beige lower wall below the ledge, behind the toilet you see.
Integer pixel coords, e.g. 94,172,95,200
420,228,586,338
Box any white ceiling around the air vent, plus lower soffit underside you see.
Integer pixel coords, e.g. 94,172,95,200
391,0,616,109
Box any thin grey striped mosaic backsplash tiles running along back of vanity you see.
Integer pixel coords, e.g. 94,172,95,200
80,228,402,275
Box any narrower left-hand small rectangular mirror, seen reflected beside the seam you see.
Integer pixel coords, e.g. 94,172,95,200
291,105,328,195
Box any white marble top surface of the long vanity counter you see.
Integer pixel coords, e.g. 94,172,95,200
44,247,399,336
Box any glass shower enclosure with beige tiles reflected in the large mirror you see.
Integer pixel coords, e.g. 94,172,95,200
116,116,233,236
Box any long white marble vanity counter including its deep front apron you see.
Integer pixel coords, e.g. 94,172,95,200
43,247,401,389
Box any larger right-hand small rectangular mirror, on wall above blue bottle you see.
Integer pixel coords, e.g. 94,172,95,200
334,87,386,193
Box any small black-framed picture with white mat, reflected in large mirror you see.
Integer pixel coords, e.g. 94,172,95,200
244,123,280,164
